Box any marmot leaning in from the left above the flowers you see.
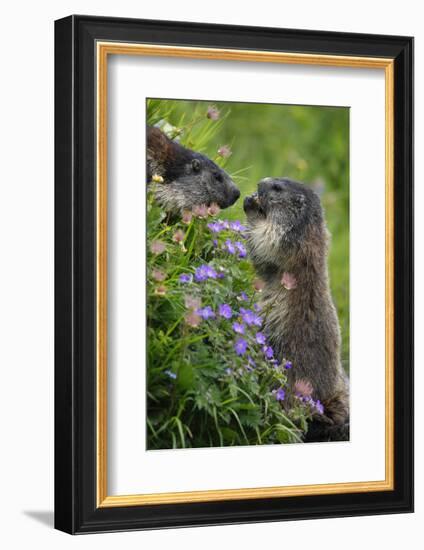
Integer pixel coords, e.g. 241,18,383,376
147,126,240,213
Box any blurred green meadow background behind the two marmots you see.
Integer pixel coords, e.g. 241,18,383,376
148,99,349,370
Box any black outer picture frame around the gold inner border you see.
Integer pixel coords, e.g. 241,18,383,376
55,15,413,534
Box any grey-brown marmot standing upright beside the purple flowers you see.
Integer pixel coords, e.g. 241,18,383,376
244,178,349,442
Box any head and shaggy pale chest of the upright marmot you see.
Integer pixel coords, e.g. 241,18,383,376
243,178,327,279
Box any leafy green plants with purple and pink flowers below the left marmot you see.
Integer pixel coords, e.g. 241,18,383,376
147,188,314,449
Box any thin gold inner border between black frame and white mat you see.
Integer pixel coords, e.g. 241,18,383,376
96,41,394,508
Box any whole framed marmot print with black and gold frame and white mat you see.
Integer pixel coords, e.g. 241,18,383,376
55,16,413,534
